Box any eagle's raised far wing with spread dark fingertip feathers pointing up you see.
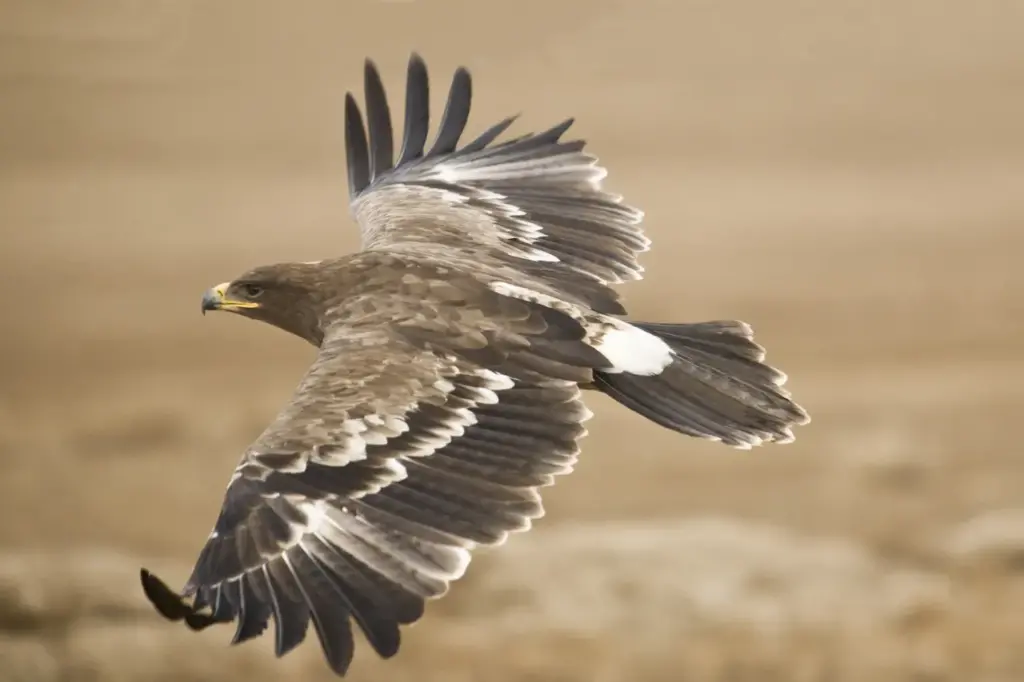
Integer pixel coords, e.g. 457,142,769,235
345,54,650,284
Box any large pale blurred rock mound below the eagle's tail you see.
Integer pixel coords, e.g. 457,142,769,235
446,518,948,642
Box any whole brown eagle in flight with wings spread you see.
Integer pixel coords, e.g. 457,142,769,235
140,52,810,677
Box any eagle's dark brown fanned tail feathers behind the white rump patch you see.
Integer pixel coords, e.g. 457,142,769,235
594,321,810,450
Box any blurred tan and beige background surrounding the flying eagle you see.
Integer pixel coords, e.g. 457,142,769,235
0,0,1024,682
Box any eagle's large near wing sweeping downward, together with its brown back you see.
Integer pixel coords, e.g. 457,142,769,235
142,260,599,675
